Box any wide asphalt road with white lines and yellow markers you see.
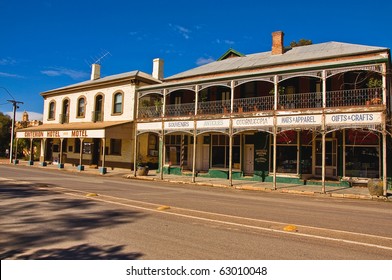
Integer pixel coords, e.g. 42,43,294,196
0,165,392,260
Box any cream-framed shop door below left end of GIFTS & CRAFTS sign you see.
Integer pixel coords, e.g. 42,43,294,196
315,139,337,179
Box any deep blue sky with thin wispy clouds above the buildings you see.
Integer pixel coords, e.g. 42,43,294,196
0,0,392,120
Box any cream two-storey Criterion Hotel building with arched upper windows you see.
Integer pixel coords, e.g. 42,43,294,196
17,64,160,172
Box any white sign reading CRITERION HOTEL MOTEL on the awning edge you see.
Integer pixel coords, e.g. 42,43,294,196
16,129,105,138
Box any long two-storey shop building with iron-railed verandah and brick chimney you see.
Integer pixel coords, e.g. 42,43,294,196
136,32,391,192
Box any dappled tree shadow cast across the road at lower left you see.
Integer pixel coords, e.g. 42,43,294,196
0,181,145,260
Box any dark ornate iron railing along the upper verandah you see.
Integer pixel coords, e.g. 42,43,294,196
138,87,383,119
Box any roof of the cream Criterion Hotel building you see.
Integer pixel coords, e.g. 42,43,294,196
41,70,162,96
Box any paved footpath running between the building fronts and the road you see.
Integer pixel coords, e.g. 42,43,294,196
0,158,392,202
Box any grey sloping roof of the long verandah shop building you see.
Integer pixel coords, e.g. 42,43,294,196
165,42,389,82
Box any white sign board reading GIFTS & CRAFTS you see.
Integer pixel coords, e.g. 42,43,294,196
325,113,382,125
